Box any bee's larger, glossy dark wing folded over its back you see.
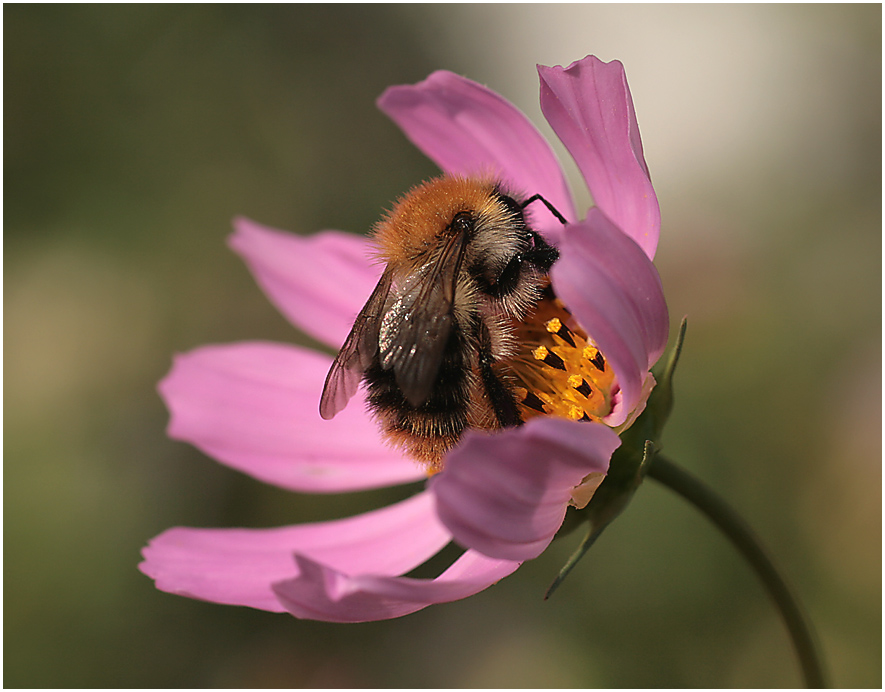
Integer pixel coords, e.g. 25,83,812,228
379,233,467,406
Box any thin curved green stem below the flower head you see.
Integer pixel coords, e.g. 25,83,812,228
648,455,826,688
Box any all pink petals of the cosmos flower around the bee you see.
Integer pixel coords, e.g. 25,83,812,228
139,56,668,622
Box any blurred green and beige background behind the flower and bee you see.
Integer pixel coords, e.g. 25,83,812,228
4,5,882,688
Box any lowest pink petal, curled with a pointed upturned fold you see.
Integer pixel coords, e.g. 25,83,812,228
274,551,520,622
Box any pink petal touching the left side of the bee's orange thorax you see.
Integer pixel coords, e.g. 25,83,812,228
229,218,382,348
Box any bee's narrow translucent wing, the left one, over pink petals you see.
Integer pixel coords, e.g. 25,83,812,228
320,269,392,420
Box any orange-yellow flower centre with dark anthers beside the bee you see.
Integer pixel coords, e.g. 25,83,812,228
506,288,614,421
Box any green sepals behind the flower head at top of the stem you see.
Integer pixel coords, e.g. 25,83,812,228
544,319,687,599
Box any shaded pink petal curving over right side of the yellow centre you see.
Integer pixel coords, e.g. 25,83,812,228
551,207,669,427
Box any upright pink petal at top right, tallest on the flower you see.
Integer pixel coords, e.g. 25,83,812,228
538,55,661,258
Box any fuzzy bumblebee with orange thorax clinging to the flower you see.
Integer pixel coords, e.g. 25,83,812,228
320,176,565,472
